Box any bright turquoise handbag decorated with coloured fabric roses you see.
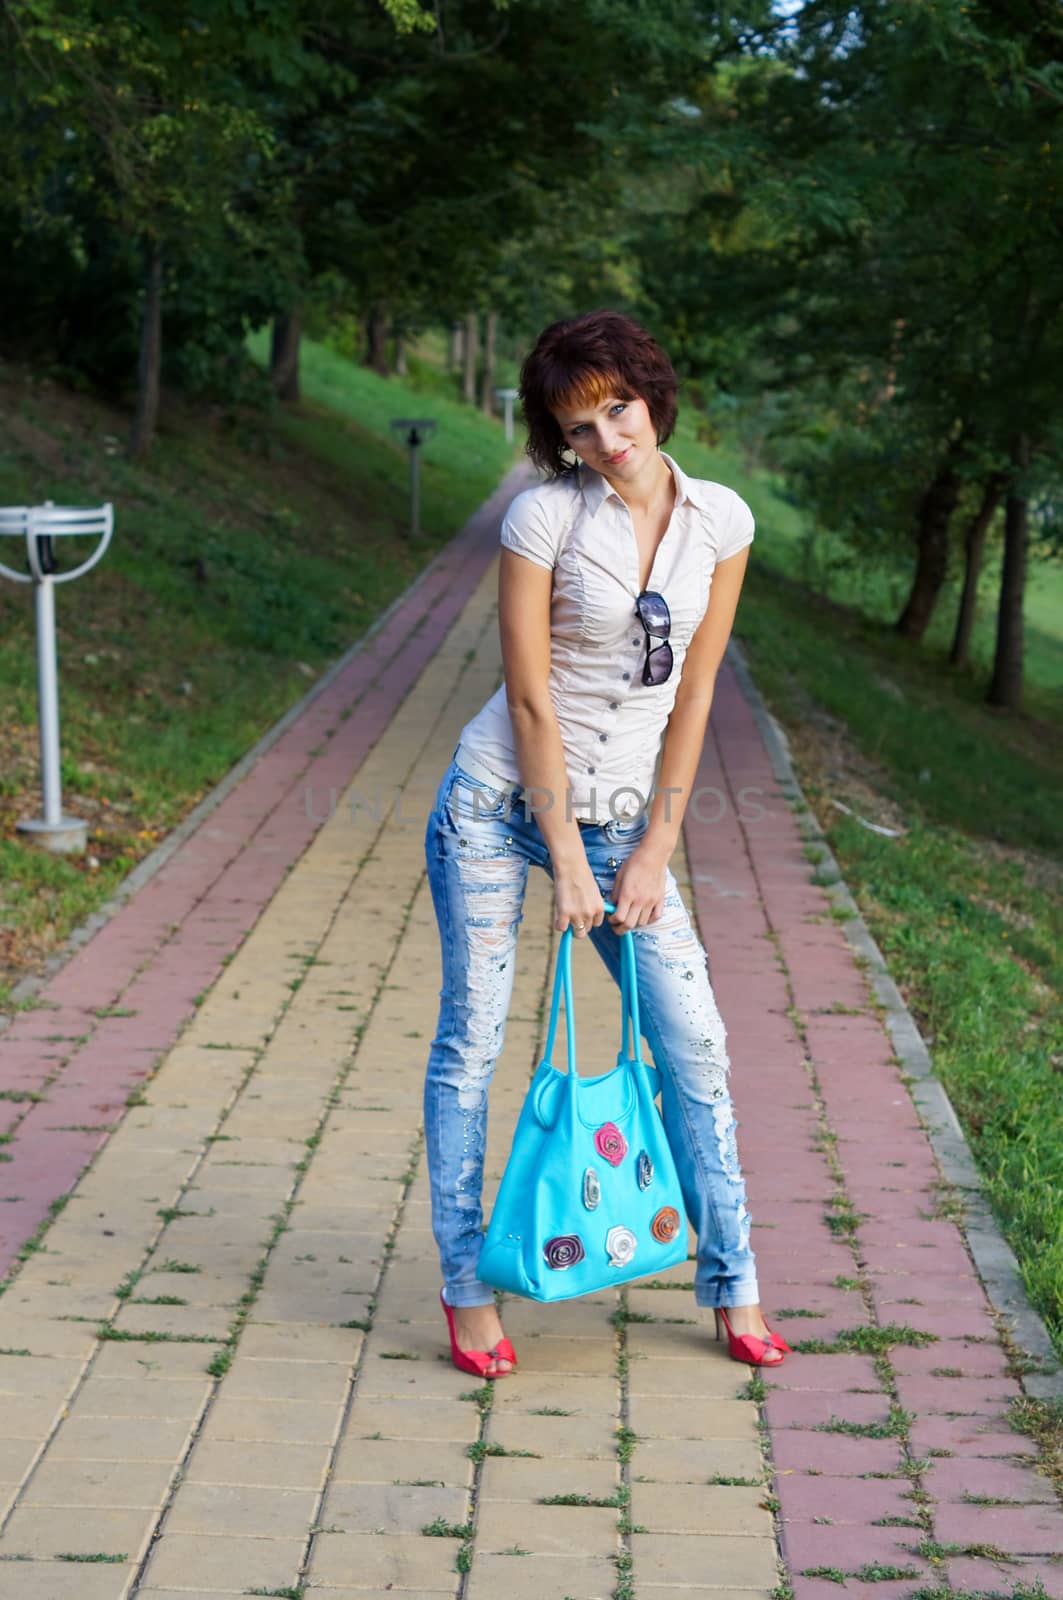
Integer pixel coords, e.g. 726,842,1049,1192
477,904,687,1301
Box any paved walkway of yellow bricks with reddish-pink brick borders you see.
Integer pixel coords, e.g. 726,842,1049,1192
0,480,1063,1600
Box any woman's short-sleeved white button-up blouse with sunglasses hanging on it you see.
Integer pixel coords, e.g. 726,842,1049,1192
461,456,754,822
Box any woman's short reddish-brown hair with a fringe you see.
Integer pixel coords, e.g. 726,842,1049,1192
520,310,679,478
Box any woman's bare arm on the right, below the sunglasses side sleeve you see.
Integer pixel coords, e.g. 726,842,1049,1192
610,547,749,933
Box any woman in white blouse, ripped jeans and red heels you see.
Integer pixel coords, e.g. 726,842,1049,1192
424,310,789,1378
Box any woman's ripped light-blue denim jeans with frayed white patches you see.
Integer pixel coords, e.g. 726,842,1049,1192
424,763,759,1306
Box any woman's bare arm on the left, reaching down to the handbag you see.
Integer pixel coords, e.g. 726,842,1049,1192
498,549,605,934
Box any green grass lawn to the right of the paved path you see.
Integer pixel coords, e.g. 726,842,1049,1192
676,412,1063,1357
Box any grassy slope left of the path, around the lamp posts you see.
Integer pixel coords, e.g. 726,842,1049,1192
0,346,517,1010
